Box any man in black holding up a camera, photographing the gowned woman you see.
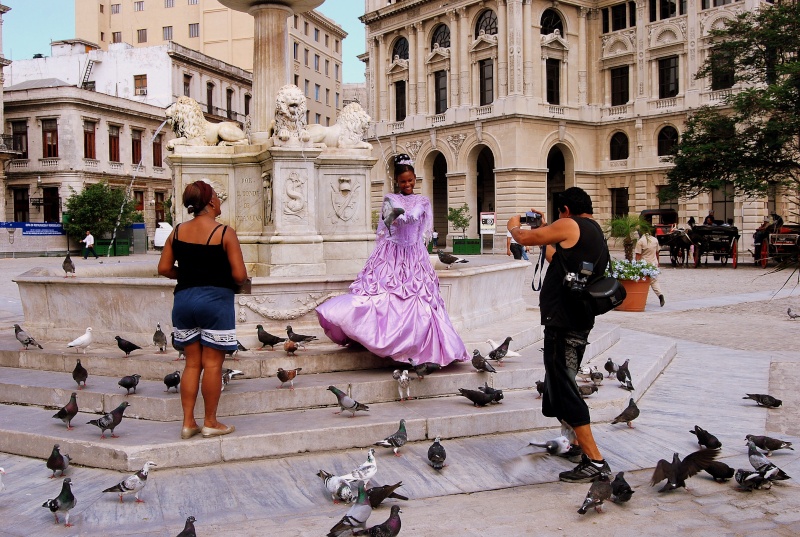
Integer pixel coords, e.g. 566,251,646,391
507,187,611,483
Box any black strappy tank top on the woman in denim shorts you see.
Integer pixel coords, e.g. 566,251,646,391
172,224,236,293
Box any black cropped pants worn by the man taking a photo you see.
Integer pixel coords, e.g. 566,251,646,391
542,326,591,428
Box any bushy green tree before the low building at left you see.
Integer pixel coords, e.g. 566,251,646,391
64,181,136,239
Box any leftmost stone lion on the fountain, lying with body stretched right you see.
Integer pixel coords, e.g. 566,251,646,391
166,95,247,149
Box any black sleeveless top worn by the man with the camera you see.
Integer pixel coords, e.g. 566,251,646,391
539,217,609,330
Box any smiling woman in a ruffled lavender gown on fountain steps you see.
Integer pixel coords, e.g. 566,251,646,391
317,154,470,365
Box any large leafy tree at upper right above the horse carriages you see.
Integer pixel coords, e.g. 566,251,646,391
660,1,800,216
